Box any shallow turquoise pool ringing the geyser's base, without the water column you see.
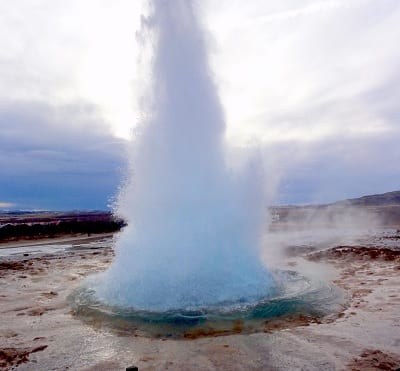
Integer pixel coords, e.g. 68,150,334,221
69,271,345,339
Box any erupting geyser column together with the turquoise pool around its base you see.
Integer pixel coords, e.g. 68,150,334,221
76,0,346,326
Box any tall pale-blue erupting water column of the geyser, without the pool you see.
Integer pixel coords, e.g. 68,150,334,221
94,0,273,312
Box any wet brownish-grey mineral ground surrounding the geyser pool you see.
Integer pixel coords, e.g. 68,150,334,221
0,229,400,370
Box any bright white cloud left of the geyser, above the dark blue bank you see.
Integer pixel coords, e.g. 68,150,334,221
0,0,141,140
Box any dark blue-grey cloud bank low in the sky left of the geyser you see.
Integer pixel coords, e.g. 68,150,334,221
0,102,125,209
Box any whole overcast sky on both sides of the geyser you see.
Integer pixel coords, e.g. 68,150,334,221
0,0,400,209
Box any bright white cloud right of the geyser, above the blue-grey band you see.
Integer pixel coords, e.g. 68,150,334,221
205,0,400,141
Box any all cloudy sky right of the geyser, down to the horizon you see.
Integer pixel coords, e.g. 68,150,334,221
205,0,400,203
